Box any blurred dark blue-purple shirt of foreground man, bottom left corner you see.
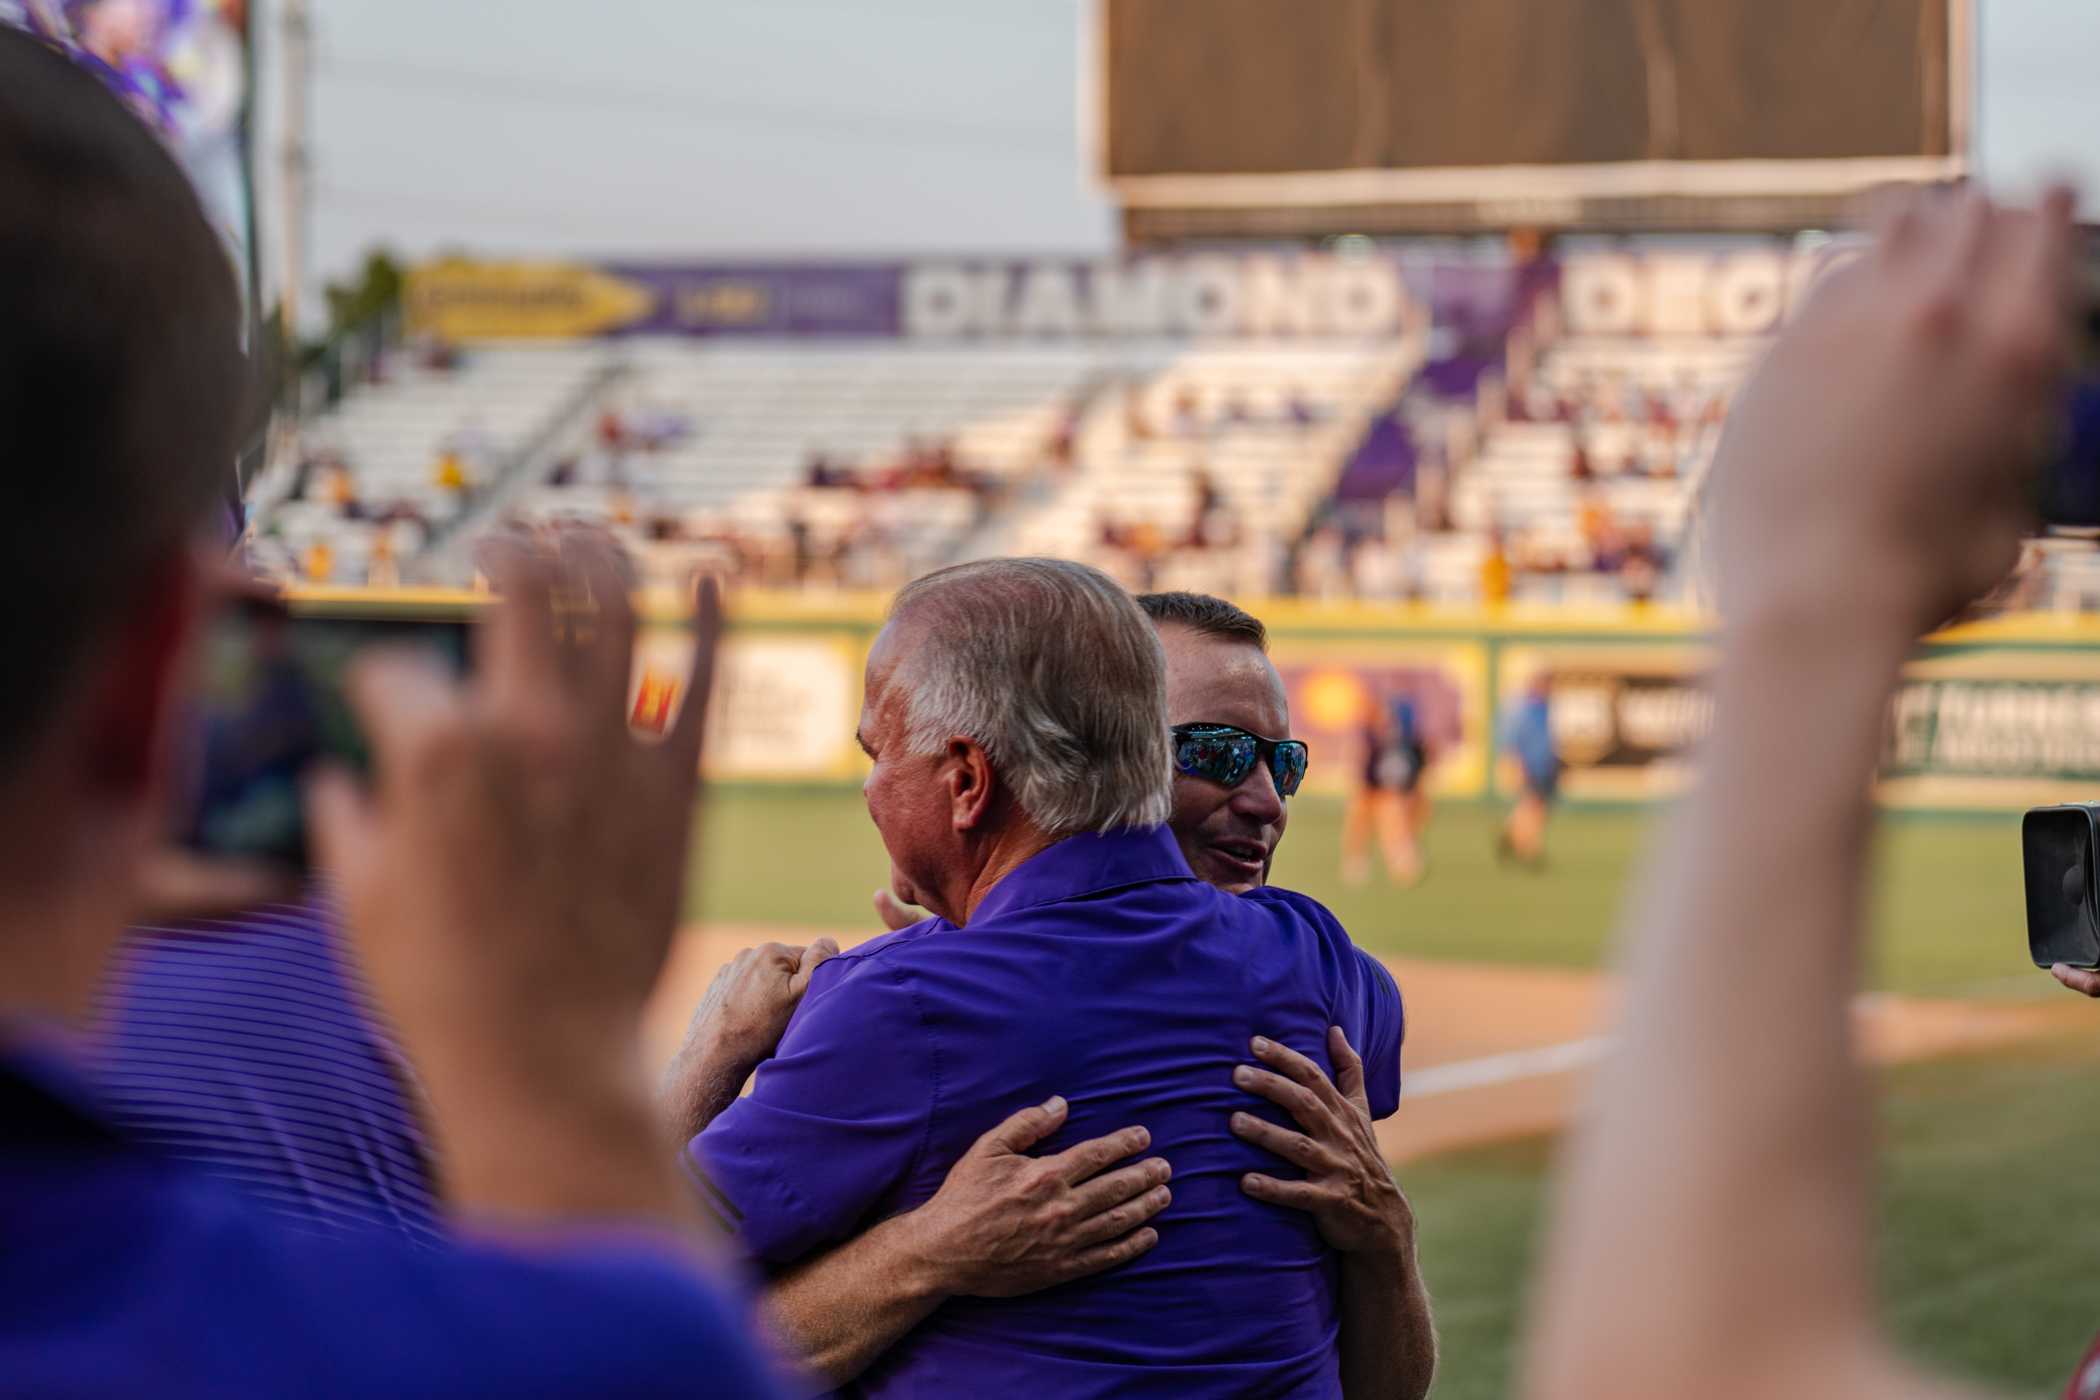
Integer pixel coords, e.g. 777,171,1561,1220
0,1041,777,1400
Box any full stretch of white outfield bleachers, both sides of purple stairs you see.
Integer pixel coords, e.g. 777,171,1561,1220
256,250,2100,607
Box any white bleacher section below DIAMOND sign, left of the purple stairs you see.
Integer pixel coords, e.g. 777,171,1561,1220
273,338,1411,604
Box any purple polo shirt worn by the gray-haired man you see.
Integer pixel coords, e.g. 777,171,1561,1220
693,829,1401,1398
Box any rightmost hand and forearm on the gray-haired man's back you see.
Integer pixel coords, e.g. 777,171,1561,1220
1233,1026,1436,1400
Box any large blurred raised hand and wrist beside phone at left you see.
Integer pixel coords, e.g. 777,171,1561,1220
309,533,720,1219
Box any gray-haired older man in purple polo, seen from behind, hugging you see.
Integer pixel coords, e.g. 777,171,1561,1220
693,558,1401,1396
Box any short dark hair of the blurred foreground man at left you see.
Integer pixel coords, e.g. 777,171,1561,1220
0,25,248,758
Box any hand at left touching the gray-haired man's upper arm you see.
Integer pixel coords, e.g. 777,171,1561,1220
664,938,838,1142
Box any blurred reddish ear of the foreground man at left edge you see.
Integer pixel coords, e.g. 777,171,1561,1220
76,548,216,804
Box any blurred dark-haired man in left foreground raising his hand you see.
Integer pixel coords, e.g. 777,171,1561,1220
0,29,769,1396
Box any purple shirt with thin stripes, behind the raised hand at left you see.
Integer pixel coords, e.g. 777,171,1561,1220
99,894,441,1240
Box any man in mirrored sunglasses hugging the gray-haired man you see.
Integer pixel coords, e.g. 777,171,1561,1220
666,592,1436,1400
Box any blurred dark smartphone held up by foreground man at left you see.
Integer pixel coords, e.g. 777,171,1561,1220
181,598,473,871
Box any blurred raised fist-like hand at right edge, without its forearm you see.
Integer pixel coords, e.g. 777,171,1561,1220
1712,193,2071,646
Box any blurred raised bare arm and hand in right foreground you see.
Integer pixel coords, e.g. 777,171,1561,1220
1525,193,2074,1400
